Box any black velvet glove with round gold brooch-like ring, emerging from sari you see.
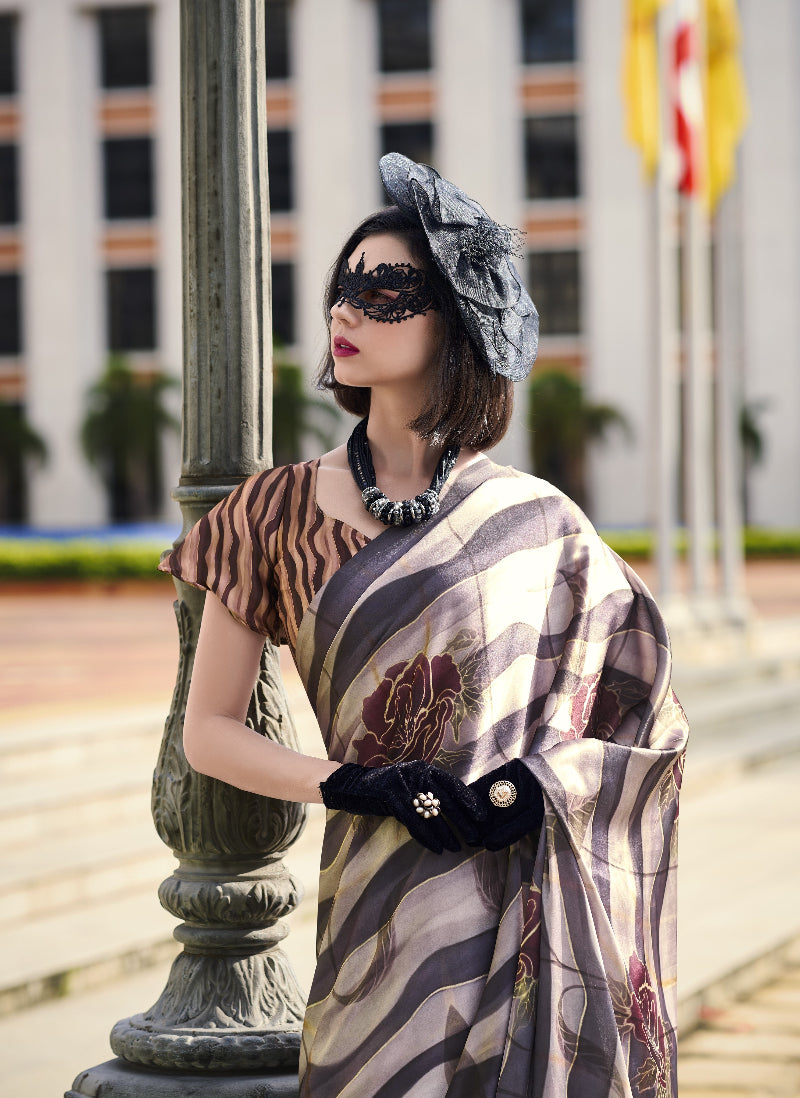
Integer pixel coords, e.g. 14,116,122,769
466,759,544,850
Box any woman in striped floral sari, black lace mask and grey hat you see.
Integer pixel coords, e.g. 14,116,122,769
165,154,687,1098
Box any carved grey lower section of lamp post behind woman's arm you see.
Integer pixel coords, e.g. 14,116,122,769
67,582,305,1098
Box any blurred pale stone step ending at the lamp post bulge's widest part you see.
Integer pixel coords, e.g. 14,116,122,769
0,759,155,850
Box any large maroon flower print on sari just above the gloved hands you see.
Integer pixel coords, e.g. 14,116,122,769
353,652,461,766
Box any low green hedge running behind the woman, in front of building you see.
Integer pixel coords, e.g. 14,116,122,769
0,528,800,581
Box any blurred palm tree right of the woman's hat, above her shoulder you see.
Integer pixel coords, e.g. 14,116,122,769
528,367,632,509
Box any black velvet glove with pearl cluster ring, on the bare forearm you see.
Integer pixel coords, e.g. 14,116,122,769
319,759,486,854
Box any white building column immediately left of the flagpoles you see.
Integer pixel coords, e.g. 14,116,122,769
578,0,656,526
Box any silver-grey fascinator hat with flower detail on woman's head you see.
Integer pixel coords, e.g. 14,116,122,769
380,153,539,381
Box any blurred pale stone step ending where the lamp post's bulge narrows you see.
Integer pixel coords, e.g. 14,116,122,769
0,818,174,932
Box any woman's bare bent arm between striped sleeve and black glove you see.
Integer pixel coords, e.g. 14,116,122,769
183,593,339,804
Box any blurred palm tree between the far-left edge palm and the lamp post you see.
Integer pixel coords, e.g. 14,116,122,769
80,355,180,522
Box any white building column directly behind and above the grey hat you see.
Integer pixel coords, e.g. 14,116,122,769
433,0,530,469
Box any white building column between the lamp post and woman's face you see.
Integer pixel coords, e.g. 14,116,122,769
291,0,381,410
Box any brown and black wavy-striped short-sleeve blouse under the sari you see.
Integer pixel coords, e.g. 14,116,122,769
159,459,370,652
